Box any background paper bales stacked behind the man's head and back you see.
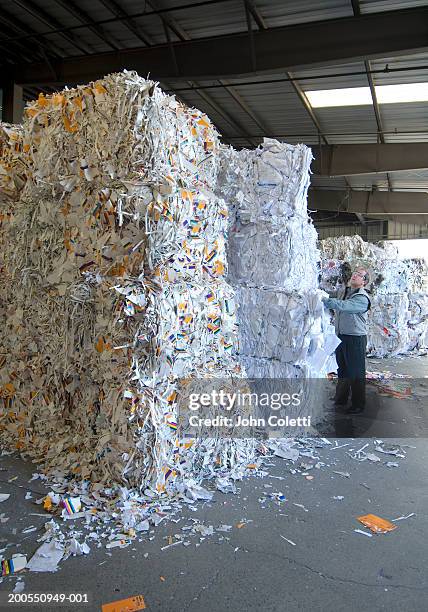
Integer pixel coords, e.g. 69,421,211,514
320,236,428,357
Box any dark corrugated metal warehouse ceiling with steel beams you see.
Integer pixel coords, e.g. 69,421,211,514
0,0,428,232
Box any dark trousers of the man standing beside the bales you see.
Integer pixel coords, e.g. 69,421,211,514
334,334,367,410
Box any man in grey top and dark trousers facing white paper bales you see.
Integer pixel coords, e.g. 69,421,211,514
323,268,371,414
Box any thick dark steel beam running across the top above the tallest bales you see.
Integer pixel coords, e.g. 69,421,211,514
5,5,428,84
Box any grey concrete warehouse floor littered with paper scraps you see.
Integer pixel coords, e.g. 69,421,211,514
0,357,428,612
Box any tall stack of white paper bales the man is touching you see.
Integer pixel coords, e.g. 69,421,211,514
219,139,337,379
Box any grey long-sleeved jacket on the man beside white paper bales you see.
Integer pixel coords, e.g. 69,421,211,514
323,287,371,336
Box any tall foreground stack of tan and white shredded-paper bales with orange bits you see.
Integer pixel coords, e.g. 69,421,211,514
0,71,251,492
